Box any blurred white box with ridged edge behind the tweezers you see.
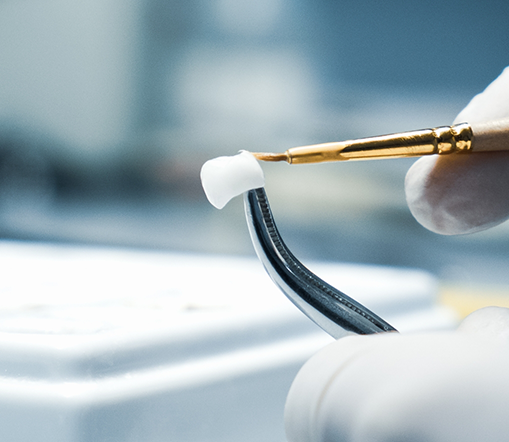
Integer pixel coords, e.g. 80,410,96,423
0,242,455,442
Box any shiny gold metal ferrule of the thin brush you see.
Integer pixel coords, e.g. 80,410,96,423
285,123,473,164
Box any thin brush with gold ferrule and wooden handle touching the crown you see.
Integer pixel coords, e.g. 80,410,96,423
253,119,509,164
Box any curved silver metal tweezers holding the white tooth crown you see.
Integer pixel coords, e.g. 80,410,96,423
244,188,396,338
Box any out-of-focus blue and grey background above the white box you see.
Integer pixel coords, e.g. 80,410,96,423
0,0,509,300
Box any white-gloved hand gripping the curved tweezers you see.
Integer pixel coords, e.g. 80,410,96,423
285,307,509,442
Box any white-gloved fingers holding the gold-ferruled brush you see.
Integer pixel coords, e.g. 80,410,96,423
405,67,509,235
